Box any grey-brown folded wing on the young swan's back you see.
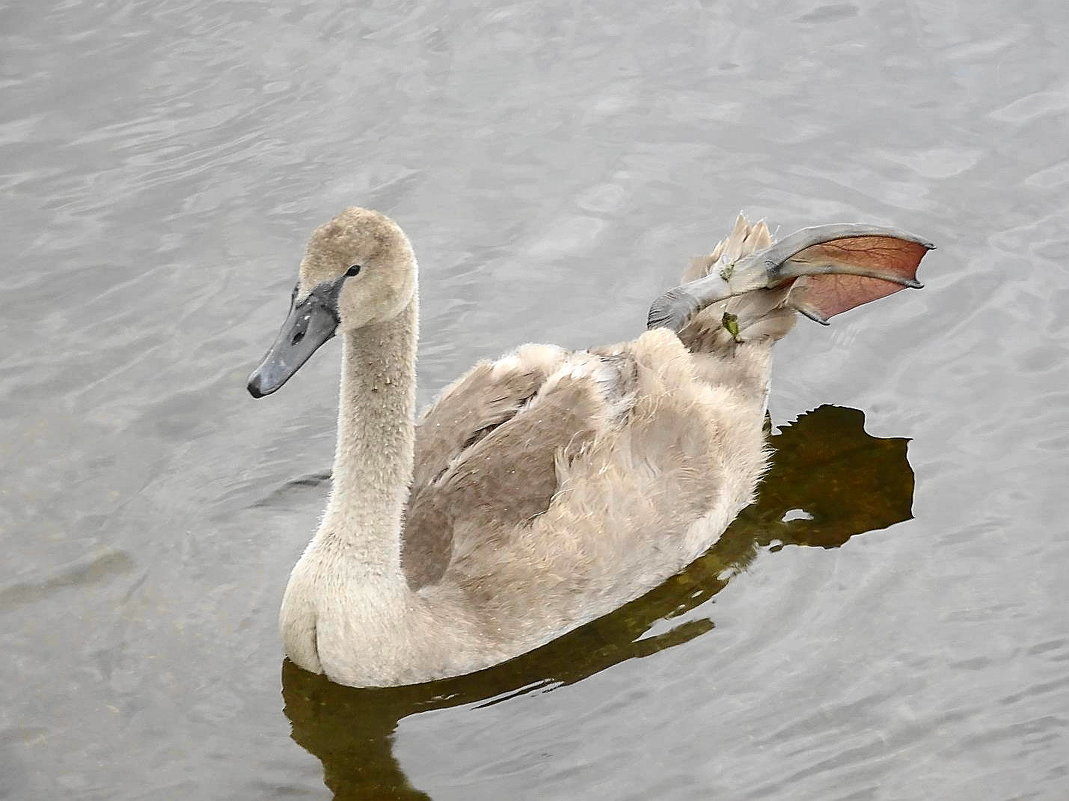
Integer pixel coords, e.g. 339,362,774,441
402,345,621,587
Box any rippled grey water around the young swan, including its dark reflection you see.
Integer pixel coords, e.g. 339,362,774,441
0,0,1069,801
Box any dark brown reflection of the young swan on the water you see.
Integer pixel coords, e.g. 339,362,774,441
282,406,913,799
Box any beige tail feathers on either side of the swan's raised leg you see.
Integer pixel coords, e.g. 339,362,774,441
679,214,795,353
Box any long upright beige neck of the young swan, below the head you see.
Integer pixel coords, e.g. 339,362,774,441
317,295,418,582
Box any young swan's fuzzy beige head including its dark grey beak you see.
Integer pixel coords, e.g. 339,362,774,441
248,207,416,398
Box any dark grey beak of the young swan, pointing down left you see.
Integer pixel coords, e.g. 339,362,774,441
249,284,338,398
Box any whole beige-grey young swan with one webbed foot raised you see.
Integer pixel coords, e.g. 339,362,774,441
249,209,931,687
